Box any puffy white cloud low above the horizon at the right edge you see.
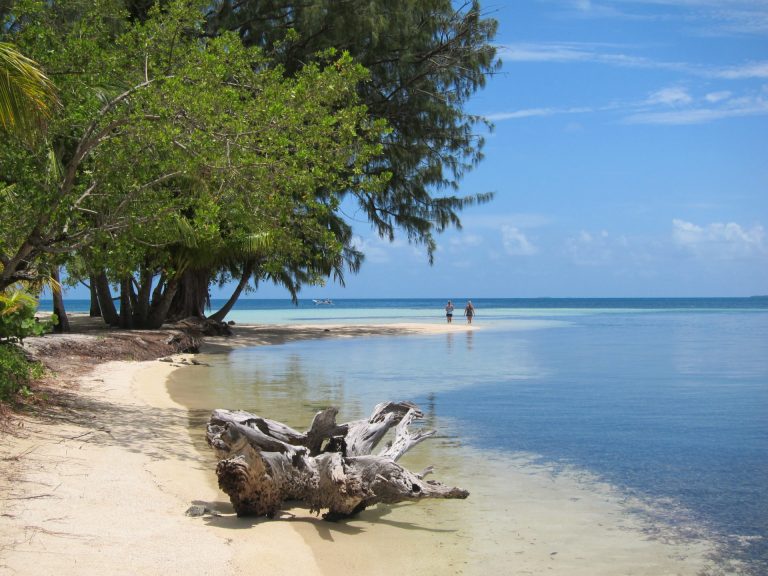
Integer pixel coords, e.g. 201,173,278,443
672,218,768,260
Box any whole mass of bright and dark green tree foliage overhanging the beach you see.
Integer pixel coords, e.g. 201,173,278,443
0,0,496,324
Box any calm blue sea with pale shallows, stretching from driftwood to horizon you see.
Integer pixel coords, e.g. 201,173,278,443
46,297,768,576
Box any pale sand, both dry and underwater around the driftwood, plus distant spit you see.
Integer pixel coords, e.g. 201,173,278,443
0,324,732,576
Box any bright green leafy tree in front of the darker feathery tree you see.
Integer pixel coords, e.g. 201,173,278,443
0,0,388,326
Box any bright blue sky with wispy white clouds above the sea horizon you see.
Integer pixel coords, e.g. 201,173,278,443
284,0,768,298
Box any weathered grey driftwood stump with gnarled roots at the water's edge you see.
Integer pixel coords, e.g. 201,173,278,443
207,402,469,520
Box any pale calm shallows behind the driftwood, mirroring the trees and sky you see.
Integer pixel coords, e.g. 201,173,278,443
170,332,547,423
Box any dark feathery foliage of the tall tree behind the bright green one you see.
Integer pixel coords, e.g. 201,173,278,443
208,0,499,257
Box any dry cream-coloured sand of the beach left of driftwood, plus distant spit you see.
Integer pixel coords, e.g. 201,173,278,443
0,315,471,576
